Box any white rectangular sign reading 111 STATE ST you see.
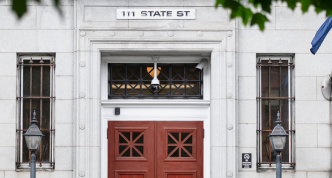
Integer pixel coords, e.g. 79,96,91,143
116,9,196,20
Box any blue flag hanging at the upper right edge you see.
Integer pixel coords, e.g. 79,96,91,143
310,17,332,54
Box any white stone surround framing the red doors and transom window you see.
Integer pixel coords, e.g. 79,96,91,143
73,29,238,178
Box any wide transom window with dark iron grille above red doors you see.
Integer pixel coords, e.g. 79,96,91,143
108,63,203,99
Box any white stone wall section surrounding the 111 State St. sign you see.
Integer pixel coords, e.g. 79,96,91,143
77,0,234,30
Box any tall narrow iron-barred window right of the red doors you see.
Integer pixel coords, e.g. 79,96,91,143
257,56,295,169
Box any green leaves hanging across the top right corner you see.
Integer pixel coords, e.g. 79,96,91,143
216,0,332,31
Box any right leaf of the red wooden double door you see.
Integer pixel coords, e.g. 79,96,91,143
156,121,203,178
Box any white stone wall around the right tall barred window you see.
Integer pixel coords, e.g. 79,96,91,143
238,4,332,178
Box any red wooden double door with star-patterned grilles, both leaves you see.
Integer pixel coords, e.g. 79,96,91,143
108,121,204,178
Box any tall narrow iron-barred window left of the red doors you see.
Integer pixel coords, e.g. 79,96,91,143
16,56,55,169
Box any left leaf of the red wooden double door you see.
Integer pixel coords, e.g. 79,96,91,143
108,121,155,178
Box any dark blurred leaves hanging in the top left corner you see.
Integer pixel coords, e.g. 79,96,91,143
11,0,61,18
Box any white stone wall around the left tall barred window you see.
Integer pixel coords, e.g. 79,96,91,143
0,0,74,178
